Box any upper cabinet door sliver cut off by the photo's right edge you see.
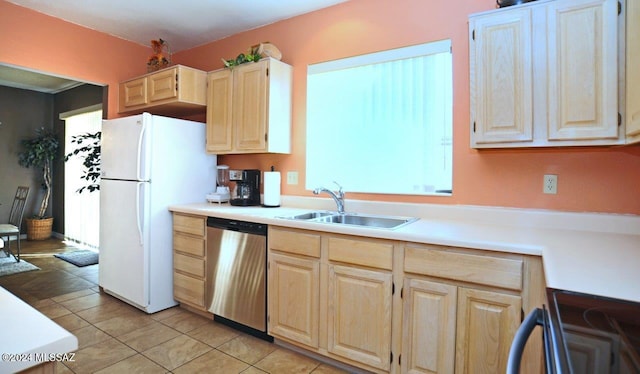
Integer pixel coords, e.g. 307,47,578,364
625,1,640,141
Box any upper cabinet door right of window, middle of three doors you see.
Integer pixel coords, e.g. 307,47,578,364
547,0,618,140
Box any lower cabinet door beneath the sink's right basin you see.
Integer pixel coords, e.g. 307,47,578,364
327,264,392,370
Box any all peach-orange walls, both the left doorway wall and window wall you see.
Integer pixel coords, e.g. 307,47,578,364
0,0,640,214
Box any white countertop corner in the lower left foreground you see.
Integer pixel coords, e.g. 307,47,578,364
0,287,78,373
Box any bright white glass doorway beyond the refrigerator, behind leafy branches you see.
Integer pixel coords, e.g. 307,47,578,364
60,105,102,250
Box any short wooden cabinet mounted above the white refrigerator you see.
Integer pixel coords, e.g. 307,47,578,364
118,65,207,115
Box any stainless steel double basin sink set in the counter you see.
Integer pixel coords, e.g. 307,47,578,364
280,211,418,230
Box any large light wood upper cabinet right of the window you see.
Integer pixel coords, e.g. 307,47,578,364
469,0,640,148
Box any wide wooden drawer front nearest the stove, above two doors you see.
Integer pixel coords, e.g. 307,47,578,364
404,245,523,290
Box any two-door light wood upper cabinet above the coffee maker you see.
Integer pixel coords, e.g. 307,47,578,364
207,58,293,154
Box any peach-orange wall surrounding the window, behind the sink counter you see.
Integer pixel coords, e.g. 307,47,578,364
178,0,640,214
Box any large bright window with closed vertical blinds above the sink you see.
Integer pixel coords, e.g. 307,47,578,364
306,40,453,194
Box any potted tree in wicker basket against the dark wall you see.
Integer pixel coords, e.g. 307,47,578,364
18,127,59,240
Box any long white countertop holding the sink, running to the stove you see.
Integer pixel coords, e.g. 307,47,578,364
169,197,640,302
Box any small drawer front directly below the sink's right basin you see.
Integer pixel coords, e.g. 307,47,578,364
329,237,393,270
